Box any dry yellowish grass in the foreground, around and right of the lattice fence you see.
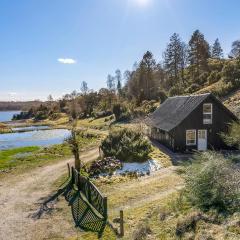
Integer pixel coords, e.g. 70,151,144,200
50,163,240,240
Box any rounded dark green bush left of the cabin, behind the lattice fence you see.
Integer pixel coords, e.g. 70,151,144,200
101,129,151,162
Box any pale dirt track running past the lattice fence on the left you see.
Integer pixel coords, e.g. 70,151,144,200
0,149,98,240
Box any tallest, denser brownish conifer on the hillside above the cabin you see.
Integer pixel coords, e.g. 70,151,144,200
188,30,210,80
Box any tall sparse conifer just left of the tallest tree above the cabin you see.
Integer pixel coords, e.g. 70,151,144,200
164,33,187,86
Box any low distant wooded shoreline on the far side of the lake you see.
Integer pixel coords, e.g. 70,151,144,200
0,101,42,111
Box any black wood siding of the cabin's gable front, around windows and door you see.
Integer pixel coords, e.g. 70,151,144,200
171,96,235,151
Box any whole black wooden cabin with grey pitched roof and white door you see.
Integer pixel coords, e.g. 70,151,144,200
146,93,238,152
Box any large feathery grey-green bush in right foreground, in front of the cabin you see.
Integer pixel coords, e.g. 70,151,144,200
185,152,240,212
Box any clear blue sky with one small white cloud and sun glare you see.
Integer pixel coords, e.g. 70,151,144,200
0,0,240,101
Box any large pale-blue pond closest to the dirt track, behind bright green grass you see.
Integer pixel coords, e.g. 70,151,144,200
0,129,70,150
